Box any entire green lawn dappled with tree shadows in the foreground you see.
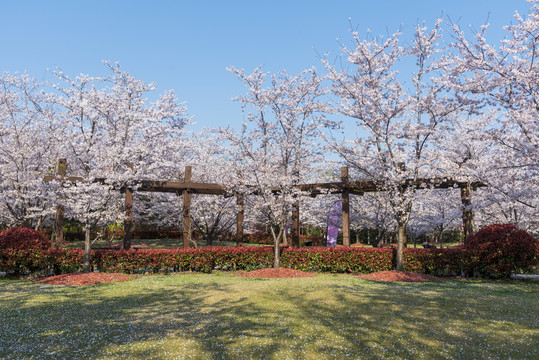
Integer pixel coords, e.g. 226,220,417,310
0,273,539,359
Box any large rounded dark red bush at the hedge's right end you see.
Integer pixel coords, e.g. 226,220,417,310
464,224,539,278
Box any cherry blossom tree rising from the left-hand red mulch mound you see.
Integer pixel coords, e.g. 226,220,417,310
53,63,189,271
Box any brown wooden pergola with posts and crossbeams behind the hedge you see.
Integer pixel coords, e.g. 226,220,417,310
44,159,486,250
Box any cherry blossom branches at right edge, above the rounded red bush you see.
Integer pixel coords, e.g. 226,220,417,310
451,1,539,231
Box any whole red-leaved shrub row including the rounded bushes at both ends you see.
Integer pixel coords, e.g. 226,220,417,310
0,224,539,277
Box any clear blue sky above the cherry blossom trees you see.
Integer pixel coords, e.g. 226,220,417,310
0,0,529,128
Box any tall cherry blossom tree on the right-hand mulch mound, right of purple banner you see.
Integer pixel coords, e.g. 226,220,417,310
324,20,462,270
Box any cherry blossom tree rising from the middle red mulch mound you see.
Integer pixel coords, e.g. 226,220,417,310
220,68,325,267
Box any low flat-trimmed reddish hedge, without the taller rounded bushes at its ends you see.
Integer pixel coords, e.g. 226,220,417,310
0,246,473,276
